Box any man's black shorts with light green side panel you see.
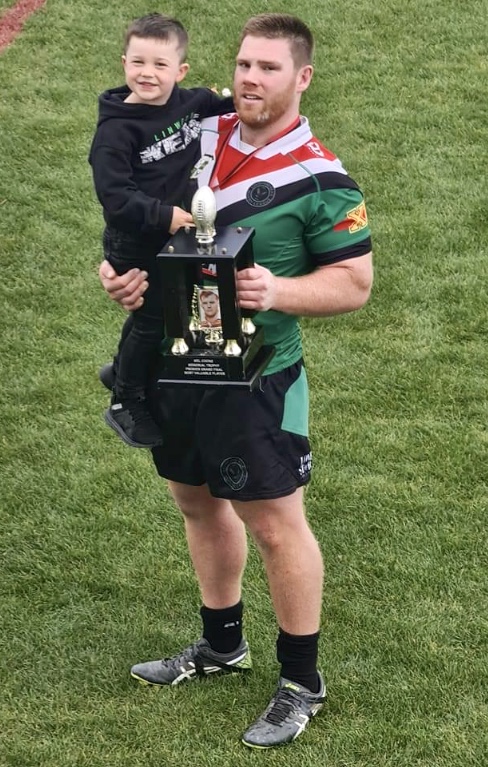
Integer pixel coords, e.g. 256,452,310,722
150,361,312,501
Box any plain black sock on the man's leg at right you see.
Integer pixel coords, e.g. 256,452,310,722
276,629,320,692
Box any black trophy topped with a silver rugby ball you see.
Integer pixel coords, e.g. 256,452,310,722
157,186,274,389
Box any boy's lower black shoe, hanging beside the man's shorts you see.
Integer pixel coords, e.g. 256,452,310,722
105,398,163,447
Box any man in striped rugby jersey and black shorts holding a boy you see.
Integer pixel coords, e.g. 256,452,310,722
100,14,372,748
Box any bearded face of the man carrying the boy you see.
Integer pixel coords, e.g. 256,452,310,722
234,35,304,130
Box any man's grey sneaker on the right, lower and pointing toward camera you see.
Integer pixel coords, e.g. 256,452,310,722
242,674,327,748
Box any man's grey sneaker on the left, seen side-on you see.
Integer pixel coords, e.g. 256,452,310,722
130,638,252,685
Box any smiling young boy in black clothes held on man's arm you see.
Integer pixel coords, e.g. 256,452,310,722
89,13,234,447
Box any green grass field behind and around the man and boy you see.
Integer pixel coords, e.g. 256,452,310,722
0,0,488,767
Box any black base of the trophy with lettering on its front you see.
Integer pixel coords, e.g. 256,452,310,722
157,346,275,389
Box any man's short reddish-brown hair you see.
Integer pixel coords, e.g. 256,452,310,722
240,13,314,69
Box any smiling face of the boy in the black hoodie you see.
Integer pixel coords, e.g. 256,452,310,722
122,36,188,106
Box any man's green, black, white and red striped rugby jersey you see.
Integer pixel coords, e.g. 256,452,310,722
193,114,371,374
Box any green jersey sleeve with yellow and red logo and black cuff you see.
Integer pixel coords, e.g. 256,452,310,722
305,183,371,266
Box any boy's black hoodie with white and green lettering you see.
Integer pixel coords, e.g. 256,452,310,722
89,85,234,239
